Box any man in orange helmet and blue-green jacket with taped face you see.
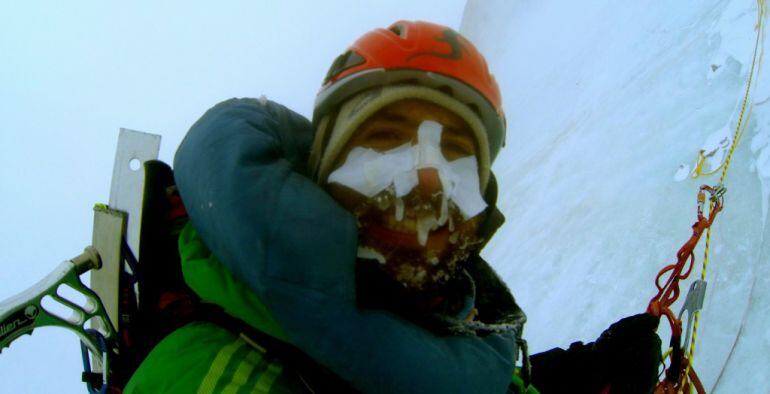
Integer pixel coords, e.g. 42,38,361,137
126,22,660,393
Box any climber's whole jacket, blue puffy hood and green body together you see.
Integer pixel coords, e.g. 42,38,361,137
127,99,536,394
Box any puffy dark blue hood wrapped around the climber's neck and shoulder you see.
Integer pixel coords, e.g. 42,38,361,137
174,99,516,393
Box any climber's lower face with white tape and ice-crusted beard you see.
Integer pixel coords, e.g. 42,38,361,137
329,121,486,290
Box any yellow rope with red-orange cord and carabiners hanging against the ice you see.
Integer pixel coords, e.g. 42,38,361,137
647,0,766,394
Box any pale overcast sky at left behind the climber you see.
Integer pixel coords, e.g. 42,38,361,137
0,0,465,393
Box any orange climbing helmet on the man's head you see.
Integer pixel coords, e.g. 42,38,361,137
313,21,505,161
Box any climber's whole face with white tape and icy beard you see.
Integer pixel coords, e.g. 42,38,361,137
328,100,485,289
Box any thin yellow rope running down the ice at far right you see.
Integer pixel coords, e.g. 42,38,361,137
684,0,766,390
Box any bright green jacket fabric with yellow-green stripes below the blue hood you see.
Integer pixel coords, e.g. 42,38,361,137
124,223,537,394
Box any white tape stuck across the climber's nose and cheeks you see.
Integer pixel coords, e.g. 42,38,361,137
329,120,487,220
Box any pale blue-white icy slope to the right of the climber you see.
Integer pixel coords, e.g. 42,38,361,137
461,0,770,393
